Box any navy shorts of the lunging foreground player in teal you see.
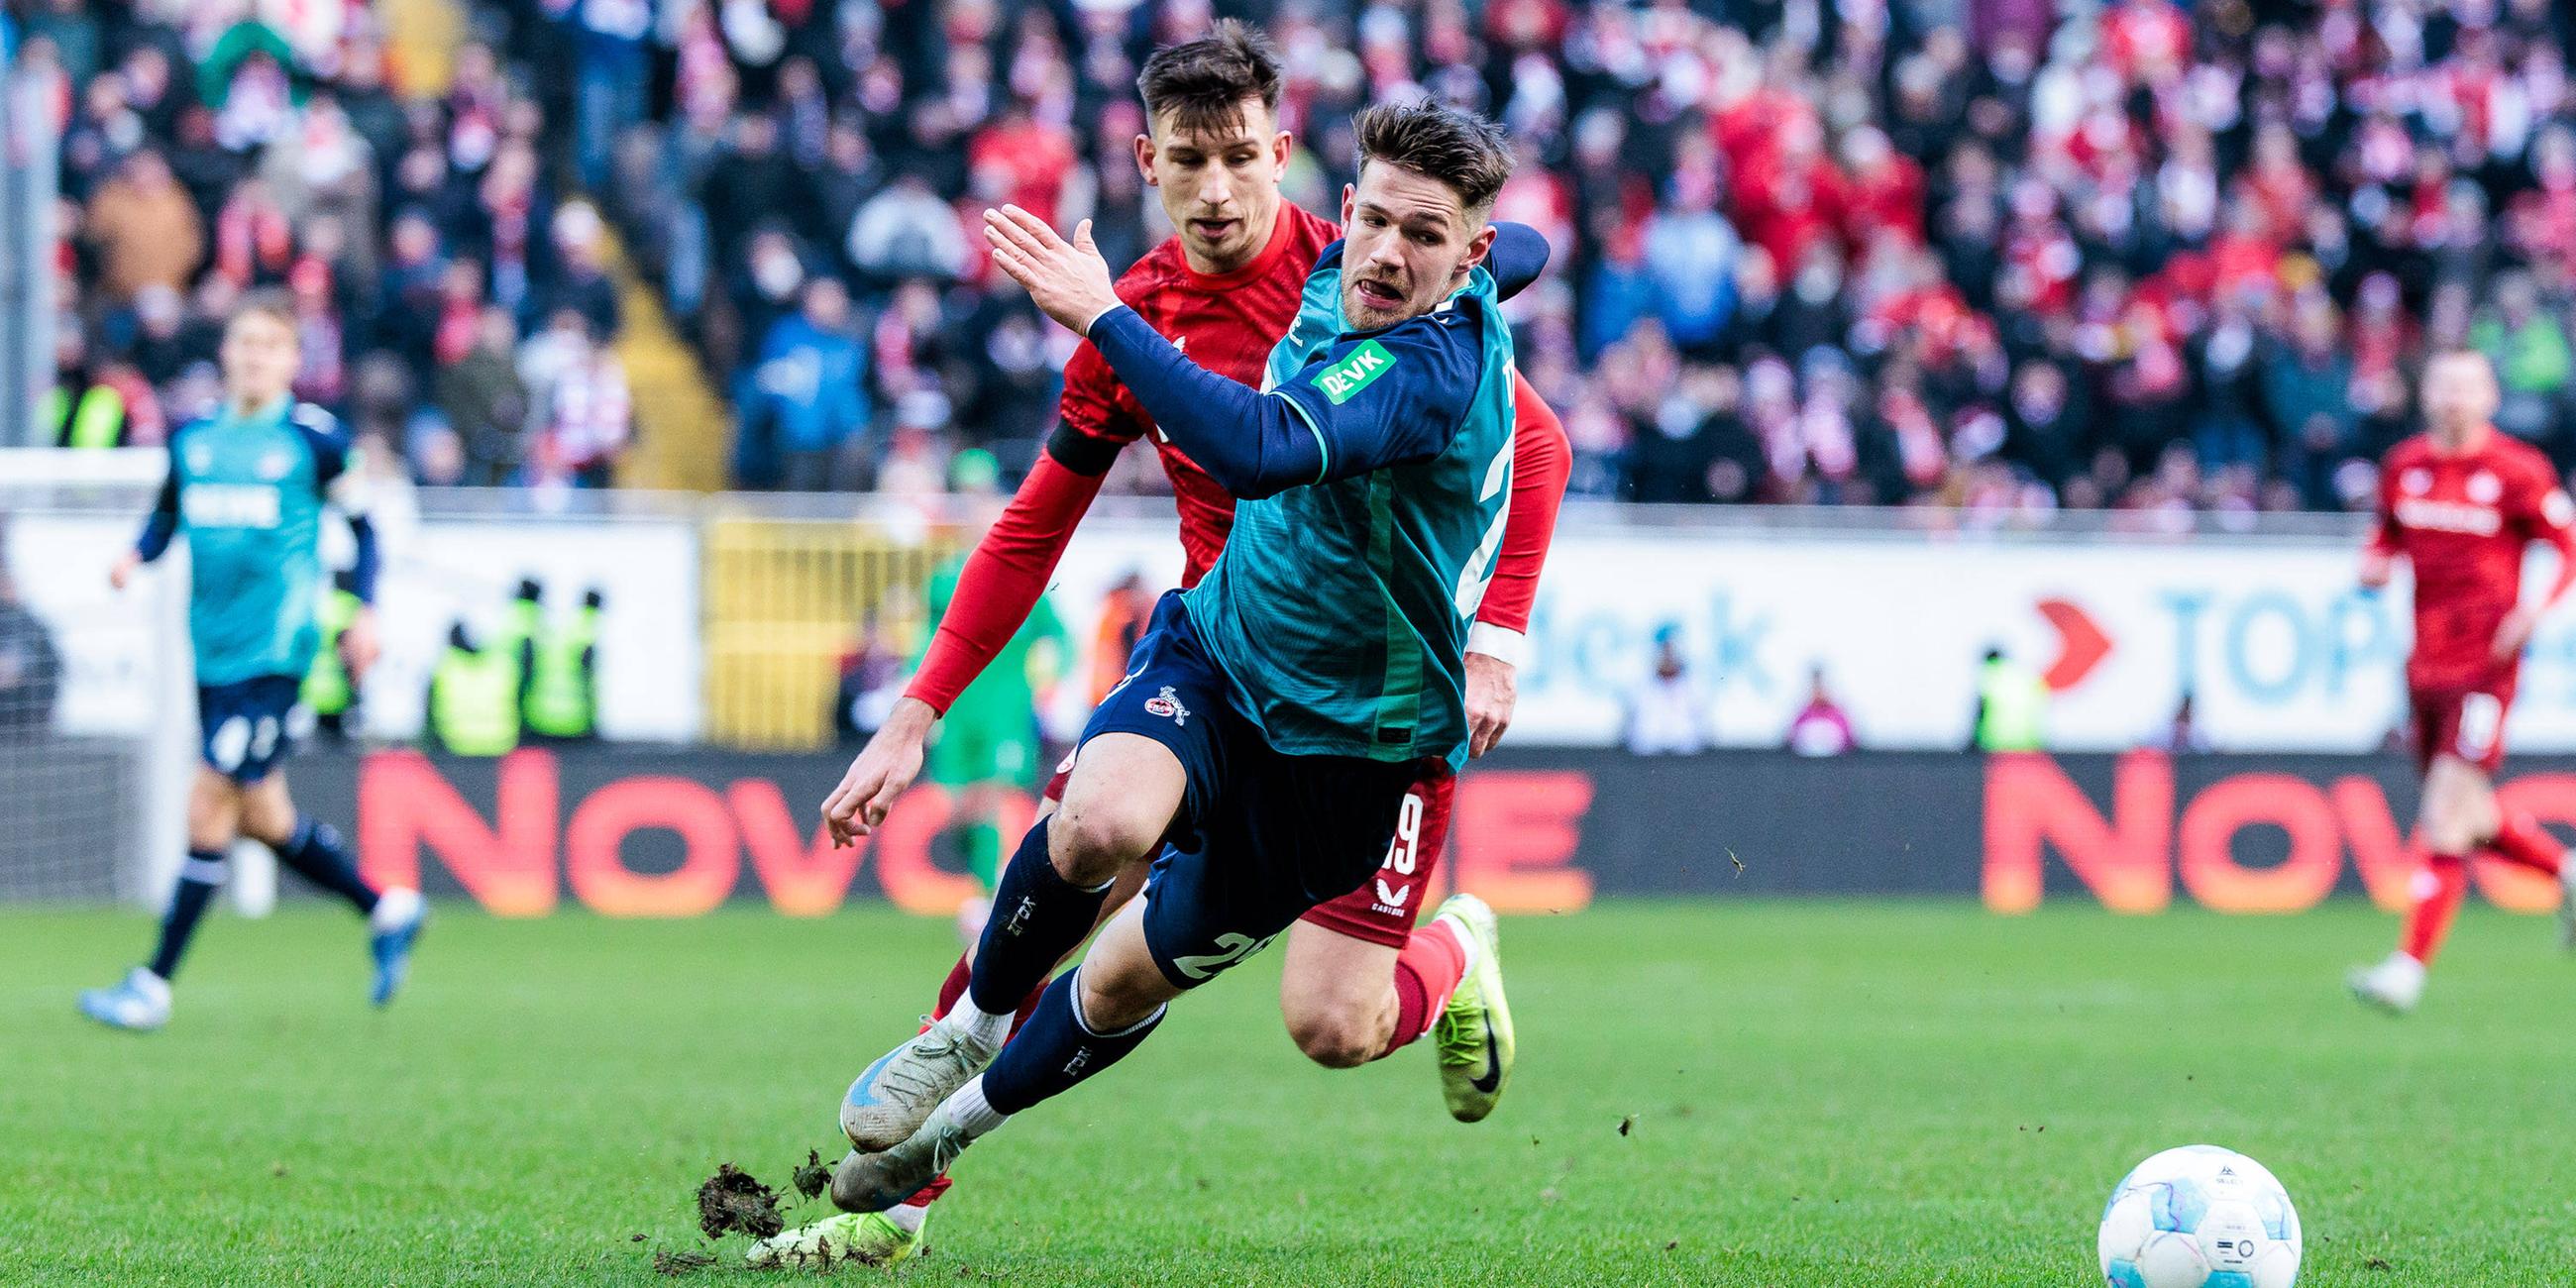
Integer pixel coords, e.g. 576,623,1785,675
1082,592,1422,989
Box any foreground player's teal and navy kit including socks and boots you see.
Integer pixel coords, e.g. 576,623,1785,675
832,227,1546,1159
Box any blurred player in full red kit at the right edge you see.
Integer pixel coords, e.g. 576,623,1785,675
2349,351,2576,1013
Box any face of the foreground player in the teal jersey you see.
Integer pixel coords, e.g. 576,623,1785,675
1342,160,1494,330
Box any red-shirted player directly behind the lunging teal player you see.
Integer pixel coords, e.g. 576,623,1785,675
755,21,1571,1262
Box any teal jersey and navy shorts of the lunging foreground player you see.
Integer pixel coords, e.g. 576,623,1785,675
1045,229,1546,987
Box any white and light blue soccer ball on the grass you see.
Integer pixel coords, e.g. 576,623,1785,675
2096,1143,2301,1288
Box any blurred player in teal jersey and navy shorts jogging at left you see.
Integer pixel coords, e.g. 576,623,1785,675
80,299,422,1030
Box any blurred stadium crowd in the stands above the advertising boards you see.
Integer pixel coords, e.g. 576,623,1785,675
25,0,2576,520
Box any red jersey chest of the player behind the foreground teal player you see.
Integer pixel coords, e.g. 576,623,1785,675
1059,201,1342,588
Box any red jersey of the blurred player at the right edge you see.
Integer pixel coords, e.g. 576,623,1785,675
2373,430,2576,688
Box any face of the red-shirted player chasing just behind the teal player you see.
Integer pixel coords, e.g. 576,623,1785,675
1136,95,1291,273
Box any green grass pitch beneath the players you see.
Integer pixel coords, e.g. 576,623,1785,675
0,902,2576,1288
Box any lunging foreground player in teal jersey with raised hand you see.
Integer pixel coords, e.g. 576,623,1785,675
824,103,1546,1211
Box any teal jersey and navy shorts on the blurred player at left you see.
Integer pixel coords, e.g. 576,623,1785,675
134,399,376,783
